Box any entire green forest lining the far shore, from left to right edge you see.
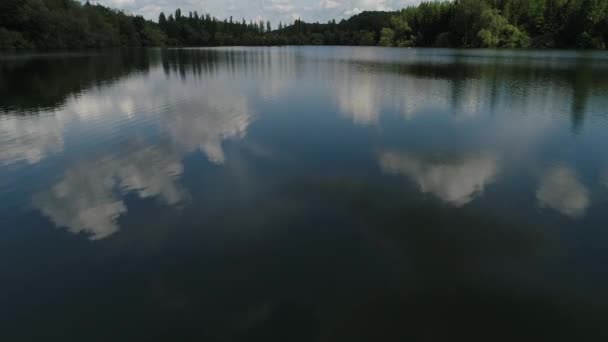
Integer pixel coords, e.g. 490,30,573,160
0,0,608,49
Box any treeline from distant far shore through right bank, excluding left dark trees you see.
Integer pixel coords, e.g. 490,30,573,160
159,0,608,49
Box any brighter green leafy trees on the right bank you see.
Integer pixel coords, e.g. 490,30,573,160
379,0,608,49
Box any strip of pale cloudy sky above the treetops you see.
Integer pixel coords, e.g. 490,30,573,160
86,0,421,26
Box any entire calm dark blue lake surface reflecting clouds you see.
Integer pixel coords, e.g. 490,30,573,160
0,47,608,341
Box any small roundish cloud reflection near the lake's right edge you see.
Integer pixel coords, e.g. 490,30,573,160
536,166,590,218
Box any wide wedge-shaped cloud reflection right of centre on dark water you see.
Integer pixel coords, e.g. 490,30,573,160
380,152,498,207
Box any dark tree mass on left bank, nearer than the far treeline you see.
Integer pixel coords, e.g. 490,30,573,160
0,0,166,49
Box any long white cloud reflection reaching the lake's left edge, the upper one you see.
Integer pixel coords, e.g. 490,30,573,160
0,61,252,168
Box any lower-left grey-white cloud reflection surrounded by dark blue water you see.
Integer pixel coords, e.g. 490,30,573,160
33,147,186,240
